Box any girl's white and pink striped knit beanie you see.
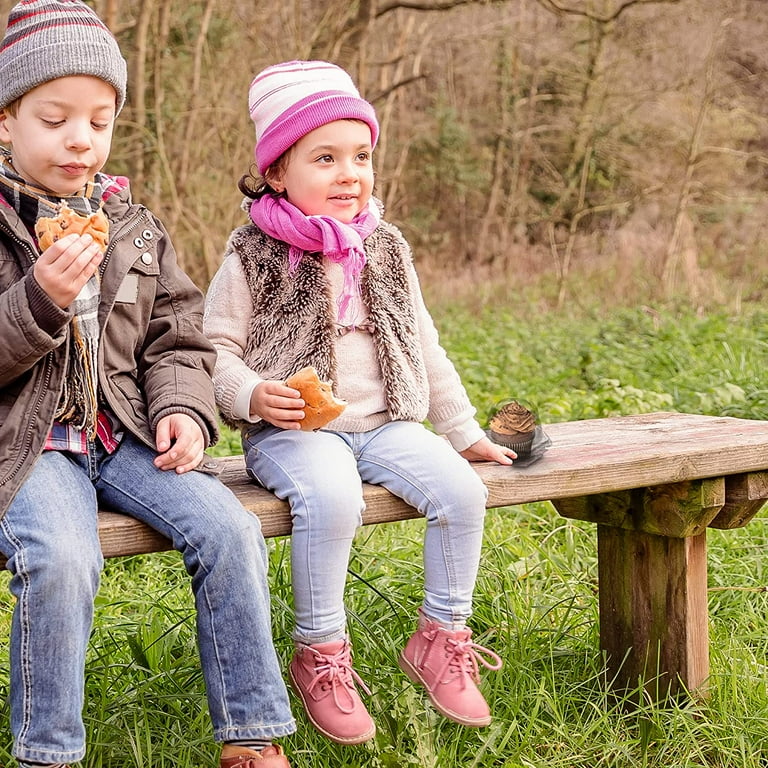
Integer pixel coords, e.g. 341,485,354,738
248,61,379,174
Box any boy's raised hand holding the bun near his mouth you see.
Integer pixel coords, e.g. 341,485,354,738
33,235,104,309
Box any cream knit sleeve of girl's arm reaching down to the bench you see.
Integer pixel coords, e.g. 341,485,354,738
411,270,485,451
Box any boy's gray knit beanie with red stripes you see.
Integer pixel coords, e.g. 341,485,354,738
0,0,128,112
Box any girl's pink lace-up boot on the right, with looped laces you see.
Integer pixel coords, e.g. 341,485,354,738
400,613,502,728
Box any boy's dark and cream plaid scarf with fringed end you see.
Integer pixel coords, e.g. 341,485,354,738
0,150,114,439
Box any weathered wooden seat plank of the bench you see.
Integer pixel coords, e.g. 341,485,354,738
94,413,768,557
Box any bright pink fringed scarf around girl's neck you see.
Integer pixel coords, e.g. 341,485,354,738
250,194,380,319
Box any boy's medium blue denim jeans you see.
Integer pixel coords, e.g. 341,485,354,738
0,436,295,763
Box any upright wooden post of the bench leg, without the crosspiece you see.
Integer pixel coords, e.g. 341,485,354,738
597,525,709,700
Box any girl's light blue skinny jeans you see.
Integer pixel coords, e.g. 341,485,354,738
243,421,487,643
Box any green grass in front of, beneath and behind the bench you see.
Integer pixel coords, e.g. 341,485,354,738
0,307,768,768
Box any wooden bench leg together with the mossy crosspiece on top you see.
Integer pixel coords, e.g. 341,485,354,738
553,486,726,699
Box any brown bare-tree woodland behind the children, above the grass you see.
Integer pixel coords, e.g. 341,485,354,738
0,0,768,309
